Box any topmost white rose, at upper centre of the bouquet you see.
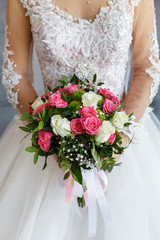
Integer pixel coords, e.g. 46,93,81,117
82,91,102,109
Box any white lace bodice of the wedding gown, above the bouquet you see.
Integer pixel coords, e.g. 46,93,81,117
21,0,139,99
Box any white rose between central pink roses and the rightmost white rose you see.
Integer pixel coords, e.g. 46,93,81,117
95,120,115,143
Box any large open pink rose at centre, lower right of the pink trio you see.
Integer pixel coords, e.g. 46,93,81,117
81,116,102,135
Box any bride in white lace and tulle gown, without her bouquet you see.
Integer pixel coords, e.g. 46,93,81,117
0,0,160,240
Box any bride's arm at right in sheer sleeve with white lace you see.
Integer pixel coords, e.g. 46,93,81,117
125,0,160,141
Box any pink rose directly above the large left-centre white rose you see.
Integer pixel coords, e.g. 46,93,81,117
49,93,67,108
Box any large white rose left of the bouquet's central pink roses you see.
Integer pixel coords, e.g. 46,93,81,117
51,115,70,138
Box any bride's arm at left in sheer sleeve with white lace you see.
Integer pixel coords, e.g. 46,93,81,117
2,0,37,113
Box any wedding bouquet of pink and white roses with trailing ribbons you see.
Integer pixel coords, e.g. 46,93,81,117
20,74,132,236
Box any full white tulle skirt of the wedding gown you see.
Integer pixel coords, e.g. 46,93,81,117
0,114,160,240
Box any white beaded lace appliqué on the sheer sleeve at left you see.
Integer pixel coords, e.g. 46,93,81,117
2,26,22,108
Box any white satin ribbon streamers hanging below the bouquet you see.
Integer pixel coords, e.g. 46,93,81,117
64,168,113,240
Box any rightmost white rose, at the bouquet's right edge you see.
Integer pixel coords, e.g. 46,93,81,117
111,112,129,131
